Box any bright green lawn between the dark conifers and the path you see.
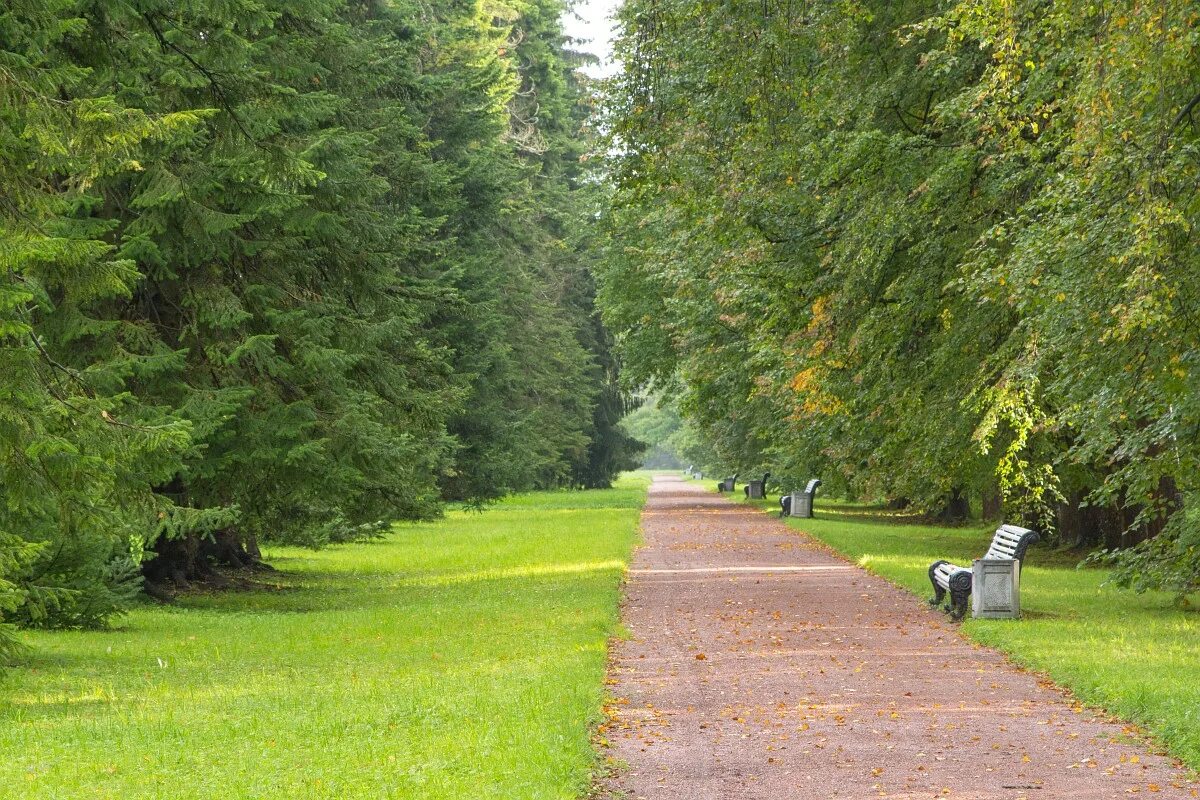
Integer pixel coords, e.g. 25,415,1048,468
0,475,648,800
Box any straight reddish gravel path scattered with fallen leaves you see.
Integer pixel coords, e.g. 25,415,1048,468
600,476,1200,800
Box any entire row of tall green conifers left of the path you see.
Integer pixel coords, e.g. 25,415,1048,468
0,0,637,649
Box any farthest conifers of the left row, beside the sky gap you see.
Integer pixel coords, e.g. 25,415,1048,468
443,0,636,500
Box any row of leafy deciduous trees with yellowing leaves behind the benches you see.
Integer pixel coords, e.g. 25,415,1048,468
600,0,1200,593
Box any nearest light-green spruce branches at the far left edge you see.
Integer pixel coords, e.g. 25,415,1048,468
0,2,196,651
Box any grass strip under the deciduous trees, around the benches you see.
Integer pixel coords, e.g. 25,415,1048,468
720,482,1200,769
